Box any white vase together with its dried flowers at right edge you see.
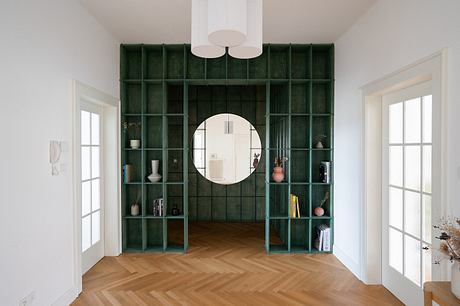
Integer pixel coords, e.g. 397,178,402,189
434,218,460,299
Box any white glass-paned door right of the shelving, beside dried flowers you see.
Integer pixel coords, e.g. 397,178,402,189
382,83,434,306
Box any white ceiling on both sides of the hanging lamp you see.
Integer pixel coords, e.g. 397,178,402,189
78,0,377,43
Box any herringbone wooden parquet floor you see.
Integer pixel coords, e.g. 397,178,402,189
73,223,403,306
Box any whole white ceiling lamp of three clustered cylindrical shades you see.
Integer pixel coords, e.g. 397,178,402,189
191,0,263,59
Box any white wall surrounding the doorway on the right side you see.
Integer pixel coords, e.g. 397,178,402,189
334,0,460,275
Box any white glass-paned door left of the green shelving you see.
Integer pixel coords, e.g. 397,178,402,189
80,103,104,274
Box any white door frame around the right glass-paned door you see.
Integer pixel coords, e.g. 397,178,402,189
359,49,450,284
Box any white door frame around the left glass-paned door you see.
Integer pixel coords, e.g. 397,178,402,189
70,80,121,295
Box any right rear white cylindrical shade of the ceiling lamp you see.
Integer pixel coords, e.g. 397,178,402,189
228,0,263,59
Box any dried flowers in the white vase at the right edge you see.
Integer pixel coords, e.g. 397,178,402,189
434,218,460,264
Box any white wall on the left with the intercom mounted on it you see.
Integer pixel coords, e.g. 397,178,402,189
0,0,119,305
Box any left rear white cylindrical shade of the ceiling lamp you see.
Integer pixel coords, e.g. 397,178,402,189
192,0,225,58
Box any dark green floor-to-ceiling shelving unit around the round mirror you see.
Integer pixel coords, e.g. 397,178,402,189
120,44,334,253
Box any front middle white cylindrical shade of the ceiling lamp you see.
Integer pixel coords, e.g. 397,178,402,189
208,0,248,47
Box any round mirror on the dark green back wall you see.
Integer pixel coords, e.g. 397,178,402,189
191,114,262,185
